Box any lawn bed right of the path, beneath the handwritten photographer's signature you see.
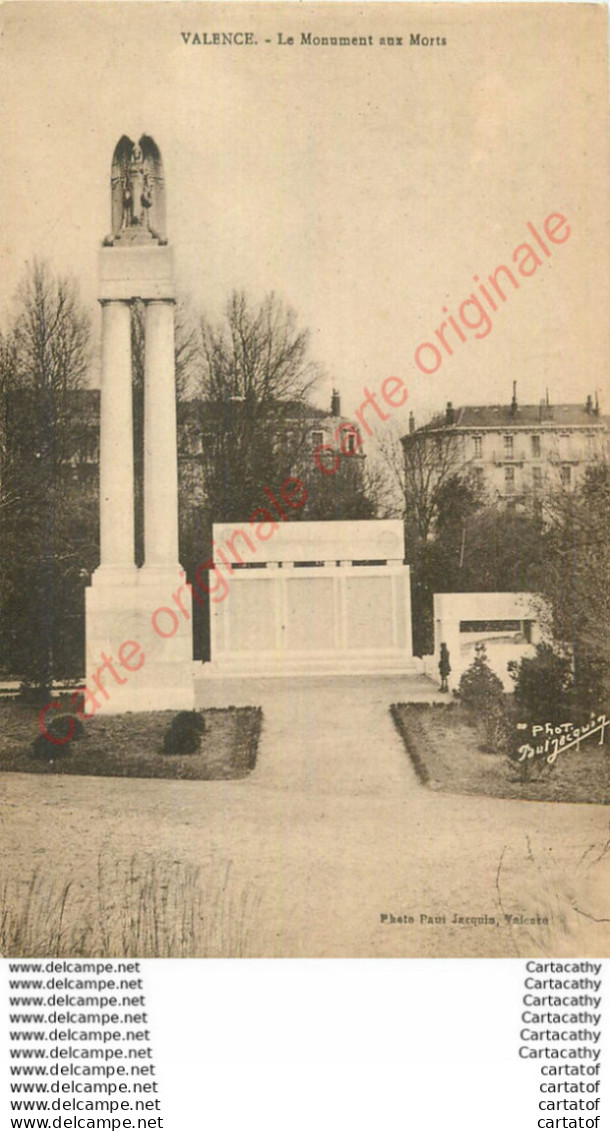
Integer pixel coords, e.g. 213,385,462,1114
390,703,610,805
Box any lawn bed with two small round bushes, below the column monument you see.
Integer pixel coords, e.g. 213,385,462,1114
0,700,263,782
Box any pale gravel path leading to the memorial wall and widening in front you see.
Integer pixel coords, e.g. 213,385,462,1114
0,676,610,957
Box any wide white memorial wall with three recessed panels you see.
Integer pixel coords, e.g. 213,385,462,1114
205,520,414,675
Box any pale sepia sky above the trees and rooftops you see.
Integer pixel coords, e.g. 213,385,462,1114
0,2,610,428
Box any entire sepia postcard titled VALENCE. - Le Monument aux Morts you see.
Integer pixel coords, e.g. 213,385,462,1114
0,0,610,960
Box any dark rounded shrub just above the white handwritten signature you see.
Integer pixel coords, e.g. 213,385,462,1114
508,644,573,723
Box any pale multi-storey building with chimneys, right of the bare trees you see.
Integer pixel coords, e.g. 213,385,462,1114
402,382,608,507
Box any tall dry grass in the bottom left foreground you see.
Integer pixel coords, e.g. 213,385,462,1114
0,855,265,958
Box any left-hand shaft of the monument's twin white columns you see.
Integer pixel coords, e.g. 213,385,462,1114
97,300,135,574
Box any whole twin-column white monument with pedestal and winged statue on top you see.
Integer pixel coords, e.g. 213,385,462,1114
86,136,195,714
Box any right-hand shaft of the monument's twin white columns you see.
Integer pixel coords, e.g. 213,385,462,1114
144,299,180,578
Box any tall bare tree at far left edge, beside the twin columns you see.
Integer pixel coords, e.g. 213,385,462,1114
0,262,95,688
